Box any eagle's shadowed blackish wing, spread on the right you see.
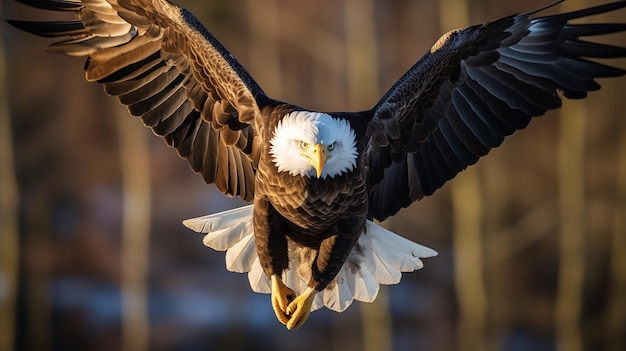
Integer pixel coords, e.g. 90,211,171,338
365,1,626,220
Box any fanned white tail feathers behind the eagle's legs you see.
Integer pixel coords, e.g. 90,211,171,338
183,205,437,312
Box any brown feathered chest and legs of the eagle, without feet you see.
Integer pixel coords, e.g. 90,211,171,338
254,123,368,291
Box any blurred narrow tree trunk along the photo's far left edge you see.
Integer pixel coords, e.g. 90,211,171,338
0,2,20,351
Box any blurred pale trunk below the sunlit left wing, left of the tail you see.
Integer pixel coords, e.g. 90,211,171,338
113,103,151,351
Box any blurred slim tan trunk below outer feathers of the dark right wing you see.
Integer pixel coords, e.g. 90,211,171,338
555,4,587,351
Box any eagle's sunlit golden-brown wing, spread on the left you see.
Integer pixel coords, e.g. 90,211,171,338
9,0,265,200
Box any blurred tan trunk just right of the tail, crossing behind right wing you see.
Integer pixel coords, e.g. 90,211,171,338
439,0,487,350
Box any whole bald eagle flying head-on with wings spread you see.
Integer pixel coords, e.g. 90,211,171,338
10,0,626,329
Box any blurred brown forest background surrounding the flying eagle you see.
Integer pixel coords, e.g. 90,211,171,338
0,0,626,351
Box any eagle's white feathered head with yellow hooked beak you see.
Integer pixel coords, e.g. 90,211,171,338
270,111,358,179
